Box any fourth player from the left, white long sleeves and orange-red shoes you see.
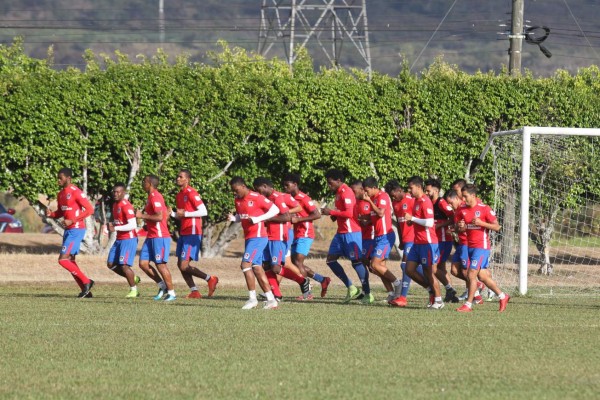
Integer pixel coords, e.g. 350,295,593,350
171,169,219,299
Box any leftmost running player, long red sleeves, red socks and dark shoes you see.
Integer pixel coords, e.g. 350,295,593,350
46,168,94,298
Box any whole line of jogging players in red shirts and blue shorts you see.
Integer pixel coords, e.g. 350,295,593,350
47,168,510,312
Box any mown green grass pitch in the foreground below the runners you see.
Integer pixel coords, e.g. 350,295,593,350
0,283,600,399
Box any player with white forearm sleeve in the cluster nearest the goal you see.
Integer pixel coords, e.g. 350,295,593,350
404,176,444,310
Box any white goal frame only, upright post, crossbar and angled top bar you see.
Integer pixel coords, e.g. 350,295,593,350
479,126,600,295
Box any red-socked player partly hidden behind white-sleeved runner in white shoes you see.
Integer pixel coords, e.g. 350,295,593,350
252,177,313,300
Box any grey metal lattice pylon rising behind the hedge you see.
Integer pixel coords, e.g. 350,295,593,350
258,0,371,78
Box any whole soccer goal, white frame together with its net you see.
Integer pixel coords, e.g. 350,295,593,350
481,127,600,295
